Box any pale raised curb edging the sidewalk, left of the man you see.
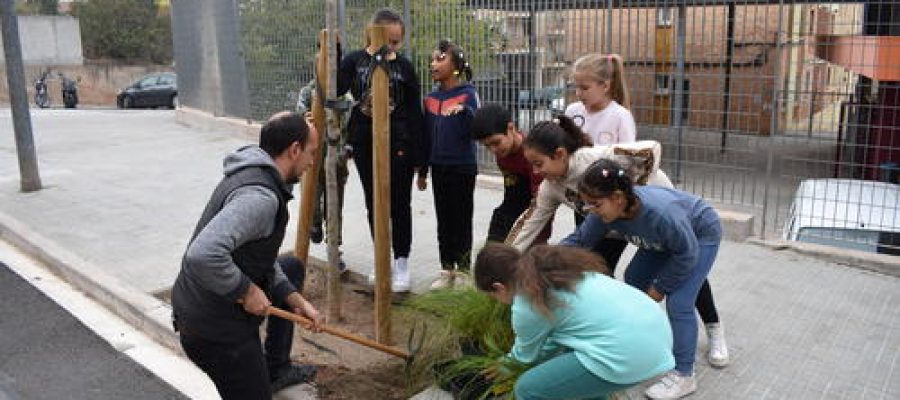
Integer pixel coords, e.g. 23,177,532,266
0,213,181,353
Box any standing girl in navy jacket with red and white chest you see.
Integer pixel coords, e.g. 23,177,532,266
418,40,480,287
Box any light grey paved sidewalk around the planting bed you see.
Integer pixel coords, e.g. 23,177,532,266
0,110,900,399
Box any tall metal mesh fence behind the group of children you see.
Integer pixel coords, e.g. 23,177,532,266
173,0,900,252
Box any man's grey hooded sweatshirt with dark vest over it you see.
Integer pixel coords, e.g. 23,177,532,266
172,146,296,342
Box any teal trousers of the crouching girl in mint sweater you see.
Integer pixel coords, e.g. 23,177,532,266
515,351,638,400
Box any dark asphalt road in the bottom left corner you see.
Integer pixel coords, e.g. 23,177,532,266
0,263,186,400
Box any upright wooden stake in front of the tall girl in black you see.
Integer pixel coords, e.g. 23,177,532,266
367,26,391,344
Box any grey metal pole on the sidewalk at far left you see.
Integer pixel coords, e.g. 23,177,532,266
0,0,41,192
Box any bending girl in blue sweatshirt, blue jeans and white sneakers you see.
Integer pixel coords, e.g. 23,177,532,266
562,159,722,399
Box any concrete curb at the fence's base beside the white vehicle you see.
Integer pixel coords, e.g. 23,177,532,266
747,238,900,278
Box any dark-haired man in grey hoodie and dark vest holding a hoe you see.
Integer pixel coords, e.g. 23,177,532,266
172,112,323,400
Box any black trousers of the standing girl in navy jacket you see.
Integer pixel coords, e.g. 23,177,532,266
431,165,478,271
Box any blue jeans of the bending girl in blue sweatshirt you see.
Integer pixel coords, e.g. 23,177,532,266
625,243,719,375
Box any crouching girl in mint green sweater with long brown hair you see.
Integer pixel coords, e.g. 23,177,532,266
475,243,675,400
